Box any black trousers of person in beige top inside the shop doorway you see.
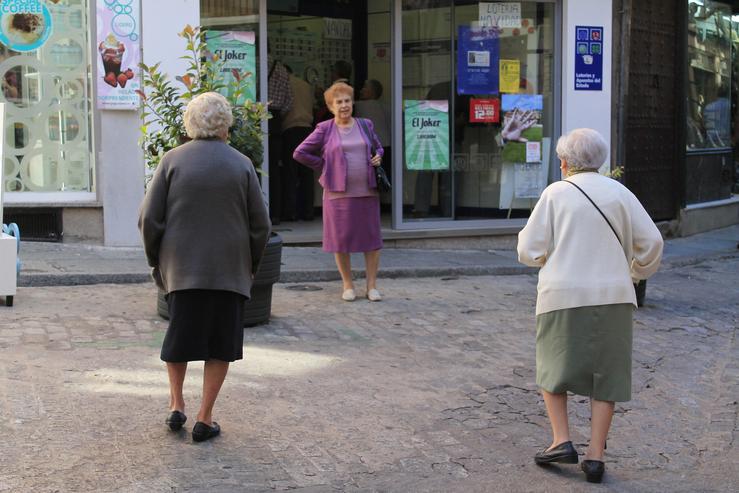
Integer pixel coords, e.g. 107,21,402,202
280,127,314,221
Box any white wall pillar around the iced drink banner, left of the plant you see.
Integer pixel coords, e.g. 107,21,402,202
101,0,200,246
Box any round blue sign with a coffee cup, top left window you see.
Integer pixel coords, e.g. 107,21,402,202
0,0,52,52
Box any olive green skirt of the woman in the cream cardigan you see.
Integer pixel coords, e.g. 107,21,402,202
536,303,634,402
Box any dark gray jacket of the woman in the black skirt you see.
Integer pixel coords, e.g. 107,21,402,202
139,139,270,298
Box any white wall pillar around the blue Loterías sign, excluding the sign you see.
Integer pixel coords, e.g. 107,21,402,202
562,0,614,165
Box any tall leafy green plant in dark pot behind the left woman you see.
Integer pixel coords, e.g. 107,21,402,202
138,25,282,326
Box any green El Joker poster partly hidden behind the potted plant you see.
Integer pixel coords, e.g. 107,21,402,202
206,30,257,104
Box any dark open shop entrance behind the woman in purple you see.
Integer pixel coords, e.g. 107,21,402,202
266,0,391,227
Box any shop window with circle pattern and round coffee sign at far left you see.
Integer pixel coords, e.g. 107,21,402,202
0,0,94,192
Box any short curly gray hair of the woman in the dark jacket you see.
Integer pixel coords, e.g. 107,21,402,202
183,92,233,139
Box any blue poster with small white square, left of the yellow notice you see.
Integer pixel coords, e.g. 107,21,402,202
457,26,500,95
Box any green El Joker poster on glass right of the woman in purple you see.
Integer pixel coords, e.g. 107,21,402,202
403,100,449,171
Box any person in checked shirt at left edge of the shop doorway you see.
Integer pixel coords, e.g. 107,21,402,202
267,48,293,225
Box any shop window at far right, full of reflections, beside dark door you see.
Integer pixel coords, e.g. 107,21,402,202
687,0,732,150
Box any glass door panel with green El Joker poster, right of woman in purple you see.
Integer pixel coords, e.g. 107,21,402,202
396,0,457,221
